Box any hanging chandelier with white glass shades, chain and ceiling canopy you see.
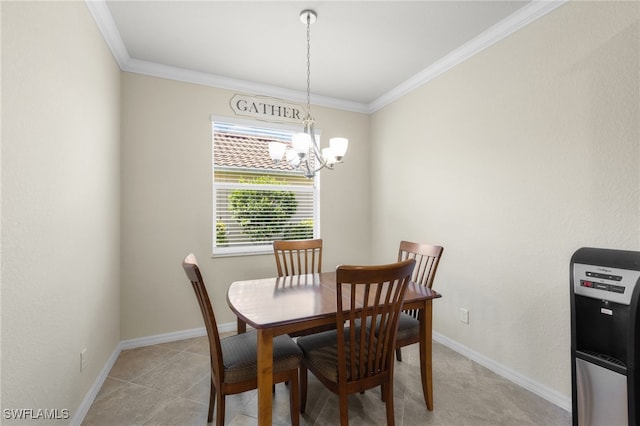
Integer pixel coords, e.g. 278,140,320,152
269,10,349,178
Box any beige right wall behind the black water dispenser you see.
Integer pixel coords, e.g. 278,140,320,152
371,2,640,397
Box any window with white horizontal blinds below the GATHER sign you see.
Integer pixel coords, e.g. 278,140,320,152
211,117,320,256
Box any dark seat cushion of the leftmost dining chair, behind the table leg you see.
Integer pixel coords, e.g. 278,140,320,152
220,331,302,383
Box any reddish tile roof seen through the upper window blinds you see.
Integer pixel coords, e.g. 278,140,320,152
213,131,294,172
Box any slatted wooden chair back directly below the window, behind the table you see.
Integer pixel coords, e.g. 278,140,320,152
273,239,322,277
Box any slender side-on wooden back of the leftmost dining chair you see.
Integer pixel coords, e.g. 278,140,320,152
182,253,224,389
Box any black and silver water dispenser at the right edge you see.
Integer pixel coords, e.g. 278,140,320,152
571,248,640,426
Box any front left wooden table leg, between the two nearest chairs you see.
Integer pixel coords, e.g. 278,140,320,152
256,328,273,426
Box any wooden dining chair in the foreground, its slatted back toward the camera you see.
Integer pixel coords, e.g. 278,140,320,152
297,259,415,426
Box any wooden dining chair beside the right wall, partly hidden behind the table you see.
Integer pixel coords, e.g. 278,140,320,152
396,241,444,361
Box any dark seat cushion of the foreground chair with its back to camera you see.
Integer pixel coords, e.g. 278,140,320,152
297,329,372,383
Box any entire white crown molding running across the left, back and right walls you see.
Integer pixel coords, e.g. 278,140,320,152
85,0,567,114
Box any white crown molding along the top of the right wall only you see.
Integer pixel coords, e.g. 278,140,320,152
368,0,567,114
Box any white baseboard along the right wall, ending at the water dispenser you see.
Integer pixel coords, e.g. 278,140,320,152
433,332,571,412
